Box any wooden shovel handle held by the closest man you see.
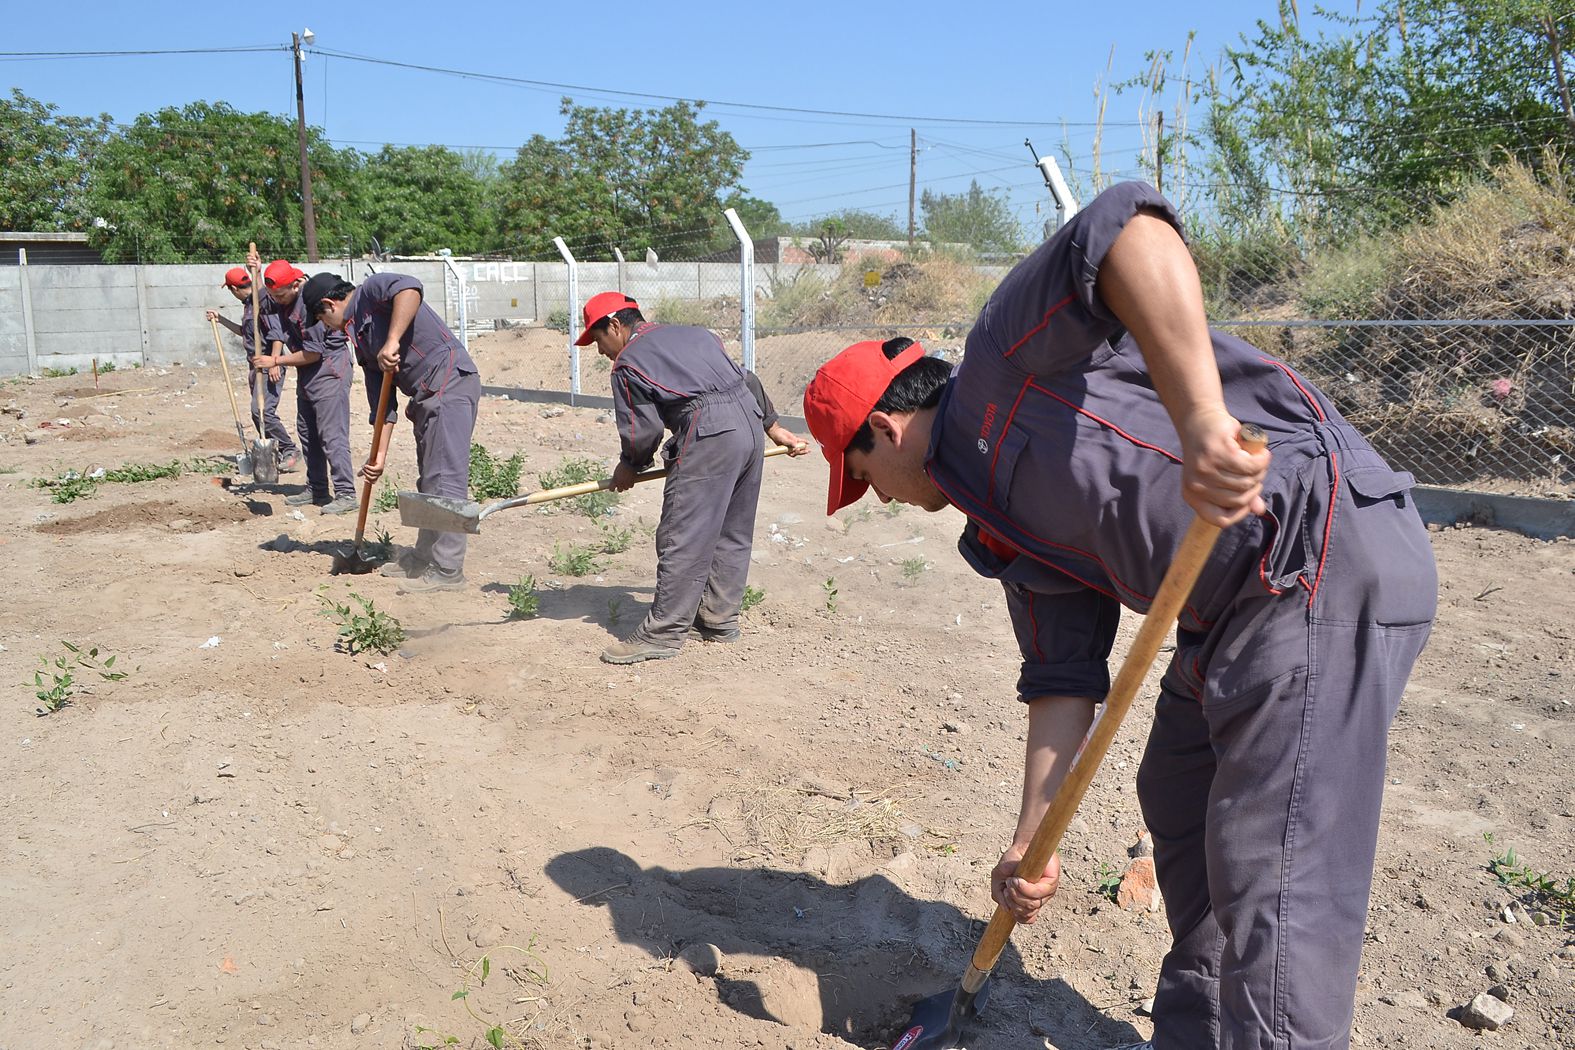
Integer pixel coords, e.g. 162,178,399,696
964,423,1268,990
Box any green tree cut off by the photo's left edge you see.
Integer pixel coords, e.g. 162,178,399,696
0,88,110,230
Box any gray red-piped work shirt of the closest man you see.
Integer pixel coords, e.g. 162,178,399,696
925,183,1413,699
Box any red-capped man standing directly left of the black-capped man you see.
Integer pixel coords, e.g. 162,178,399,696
252,258,361,515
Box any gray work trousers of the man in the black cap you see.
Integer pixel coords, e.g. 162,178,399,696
409,372,482,575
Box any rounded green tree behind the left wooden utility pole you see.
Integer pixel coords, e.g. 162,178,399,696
87,102,365,263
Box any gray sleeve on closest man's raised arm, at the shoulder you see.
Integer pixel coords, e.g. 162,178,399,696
977,183,1181,375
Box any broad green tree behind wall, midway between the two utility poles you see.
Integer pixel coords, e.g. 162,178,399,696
501,98,750,258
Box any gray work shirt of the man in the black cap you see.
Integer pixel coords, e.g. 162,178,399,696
345,274,477,419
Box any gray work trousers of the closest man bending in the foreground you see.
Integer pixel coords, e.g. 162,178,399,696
1137,452,1438,1050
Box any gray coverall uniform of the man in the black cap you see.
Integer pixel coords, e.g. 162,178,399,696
345,274,482,575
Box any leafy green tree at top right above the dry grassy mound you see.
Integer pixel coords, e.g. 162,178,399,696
1206,0,1575,244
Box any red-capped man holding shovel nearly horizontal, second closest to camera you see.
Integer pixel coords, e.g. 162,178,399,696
575,291,810,664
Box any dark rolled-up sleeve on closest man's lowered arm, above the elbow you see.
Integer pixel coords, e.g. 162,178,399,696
1002,582,1121,702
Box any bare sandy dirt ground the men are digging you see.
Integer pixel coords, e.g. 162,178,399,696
0,340,1575,1050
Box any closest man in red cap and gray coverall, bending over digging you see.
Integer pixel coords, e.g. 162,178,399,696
805,183,1436,1050
